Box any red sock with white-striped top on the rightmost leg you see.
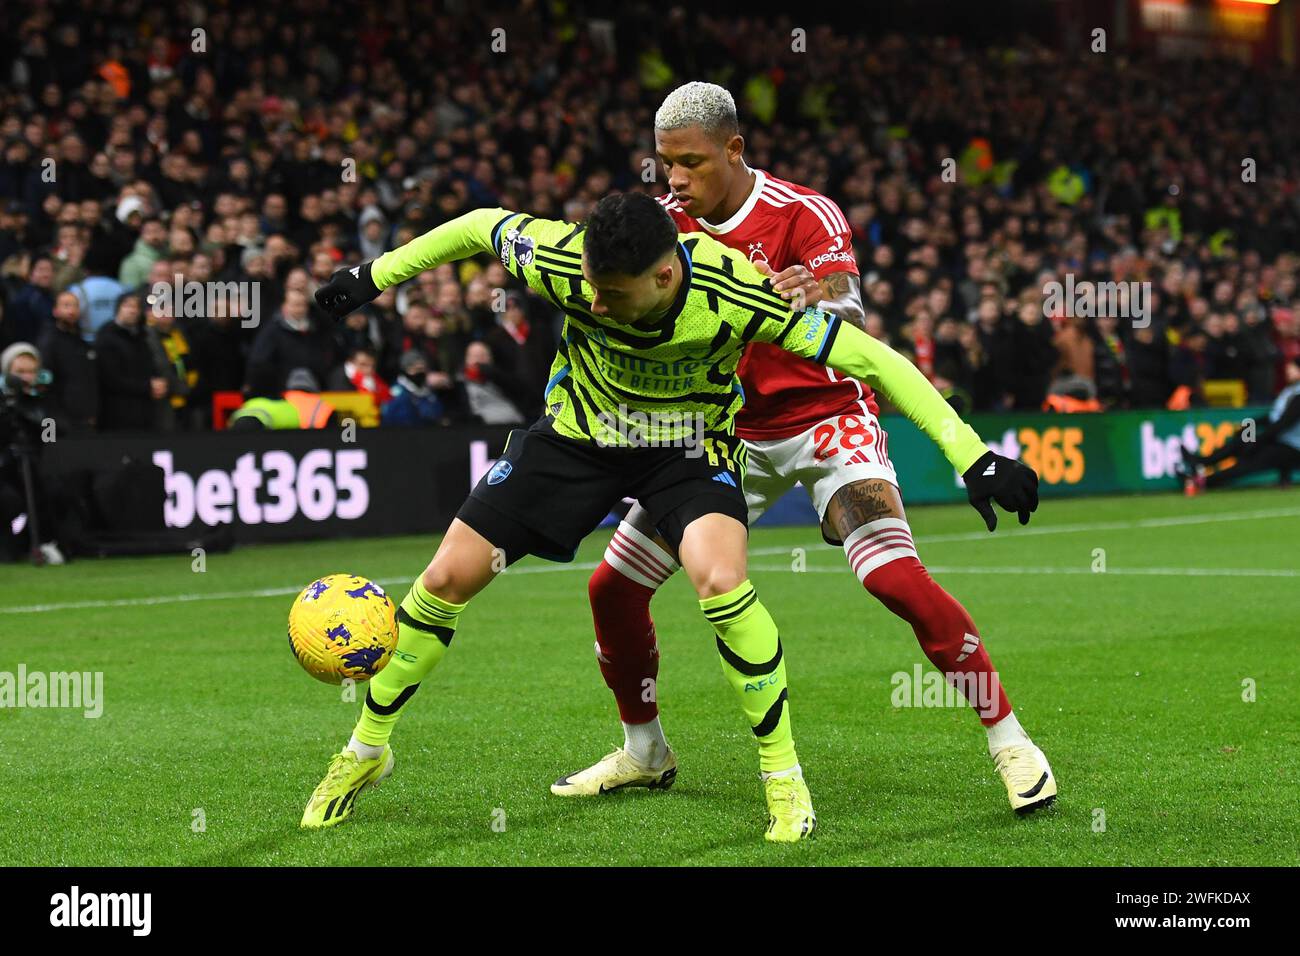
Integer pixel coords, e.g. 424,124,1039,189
845,519,1011,727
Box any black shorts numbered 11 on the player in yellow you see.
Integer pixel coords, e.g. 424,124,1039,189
456,419,749,563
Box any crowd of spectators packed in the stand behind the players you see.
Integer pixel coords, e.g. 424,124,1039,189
0,0,1300,429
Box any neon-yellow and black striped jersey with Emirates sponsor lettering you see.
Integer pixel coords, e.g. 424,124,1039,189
491,213,839,445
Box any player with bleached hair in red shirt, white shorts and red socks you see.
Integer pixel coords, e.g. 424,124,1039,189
551,82,1057,813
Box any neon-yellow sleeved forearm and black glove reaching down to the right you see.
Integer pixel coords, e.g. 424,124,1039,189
824,323,1039,531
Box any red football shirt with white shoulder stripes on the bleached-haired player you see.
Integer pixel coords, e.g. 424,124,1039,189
659,169,880,441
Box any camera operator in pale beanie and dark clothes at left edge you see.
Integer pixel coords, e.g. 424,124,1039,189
0,342,64,564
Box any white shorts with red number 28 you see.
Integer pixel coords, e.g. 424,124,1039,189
745,403,898,545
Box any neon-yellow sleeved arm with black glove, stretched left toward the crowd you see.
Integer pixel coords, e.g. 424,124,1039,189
316,209,511,319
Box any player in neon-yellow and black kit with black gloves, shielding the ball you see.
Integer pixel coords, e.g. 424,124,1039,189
302,194,1037,842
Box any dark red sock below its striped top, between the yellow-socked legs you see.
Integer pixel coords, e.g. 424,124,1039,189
588,561,659,723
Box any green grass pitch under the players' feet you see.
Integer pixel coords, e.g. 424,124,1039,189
0,489,1300,866
